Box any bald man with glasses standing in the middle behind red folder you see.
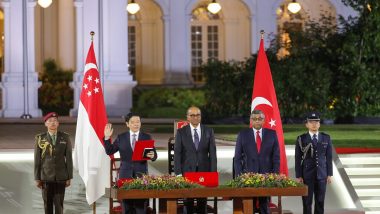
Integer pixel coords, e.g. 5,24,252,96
174,106,217,213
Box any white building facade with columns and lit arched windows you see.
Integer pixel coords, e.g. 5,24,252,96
0,0,355,117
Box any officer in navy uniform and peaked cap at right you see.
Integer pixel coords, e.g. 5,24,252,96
295,112,333,214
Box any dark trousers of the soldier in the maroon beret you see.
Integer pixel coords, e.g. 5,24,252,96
42,181,66,214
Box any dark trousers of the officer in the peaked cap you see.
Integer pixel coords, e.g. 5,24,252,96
302,179,327,214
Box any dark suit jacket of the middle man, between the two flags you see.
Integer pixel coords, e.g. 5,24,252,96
174,125,217,175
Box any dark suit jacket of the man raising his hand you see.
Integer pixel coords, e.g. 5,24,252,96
104,131,157,178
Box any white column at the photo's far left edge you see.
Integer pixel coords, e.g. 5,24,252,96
1,0,42,117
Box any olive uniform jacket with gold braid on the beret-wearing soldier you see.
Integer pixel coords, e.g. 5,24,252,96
34,131,73,181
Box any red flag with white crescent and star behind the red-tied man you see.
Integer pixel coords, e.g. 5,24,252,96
251,39,288,175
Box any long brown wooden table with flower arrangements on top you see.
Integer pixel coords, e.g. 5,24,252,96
106,186,307,214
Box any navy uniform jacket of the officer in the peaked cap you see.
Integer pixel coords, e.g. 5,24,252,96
295,132,333,180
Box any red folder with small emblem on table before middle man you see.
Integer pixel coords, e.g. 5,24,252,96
185,172,219,187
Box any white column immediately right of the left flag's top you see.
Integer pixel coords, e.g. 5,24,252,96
103,0,137,117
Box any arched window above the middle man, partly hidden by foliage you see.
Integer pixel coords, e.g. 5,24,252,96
190,3,224,83
